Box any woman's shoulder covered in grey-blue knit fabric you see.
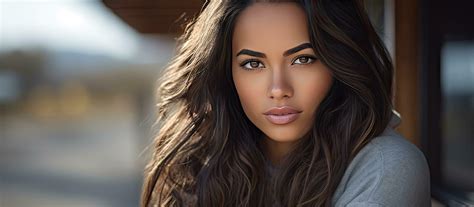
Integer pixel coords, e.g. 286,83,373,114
333,128,431,206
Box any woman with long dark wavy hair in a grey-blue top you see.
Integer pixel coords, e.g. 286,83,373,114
142,0,430,207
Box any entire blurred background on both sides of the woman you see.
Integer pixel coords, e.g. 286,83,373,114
0,0,474,207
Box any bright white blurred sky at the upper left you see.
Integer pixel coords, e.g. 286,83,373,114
0,0,140,60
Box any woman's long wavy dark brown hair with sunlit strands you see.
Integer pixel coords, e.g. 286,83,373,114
141,0,393,207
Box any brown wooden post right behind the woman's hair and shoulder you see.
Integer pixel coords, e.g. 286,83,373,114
395,0,421,146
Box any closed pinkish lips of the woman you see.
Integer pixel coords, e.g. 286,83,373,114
263,106,302,125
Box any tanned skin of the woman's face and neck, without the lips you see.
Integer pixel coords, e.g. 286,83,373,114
232,2,333,164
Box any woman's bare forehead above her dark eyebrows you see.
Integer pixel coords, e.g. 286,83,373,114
232,2,309,52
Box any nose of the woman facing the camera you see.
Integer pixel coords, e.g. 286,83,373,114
268,69,293,100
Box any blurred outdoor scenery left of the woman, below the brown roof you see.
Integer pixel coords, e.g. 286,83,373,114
0,0,175,207
